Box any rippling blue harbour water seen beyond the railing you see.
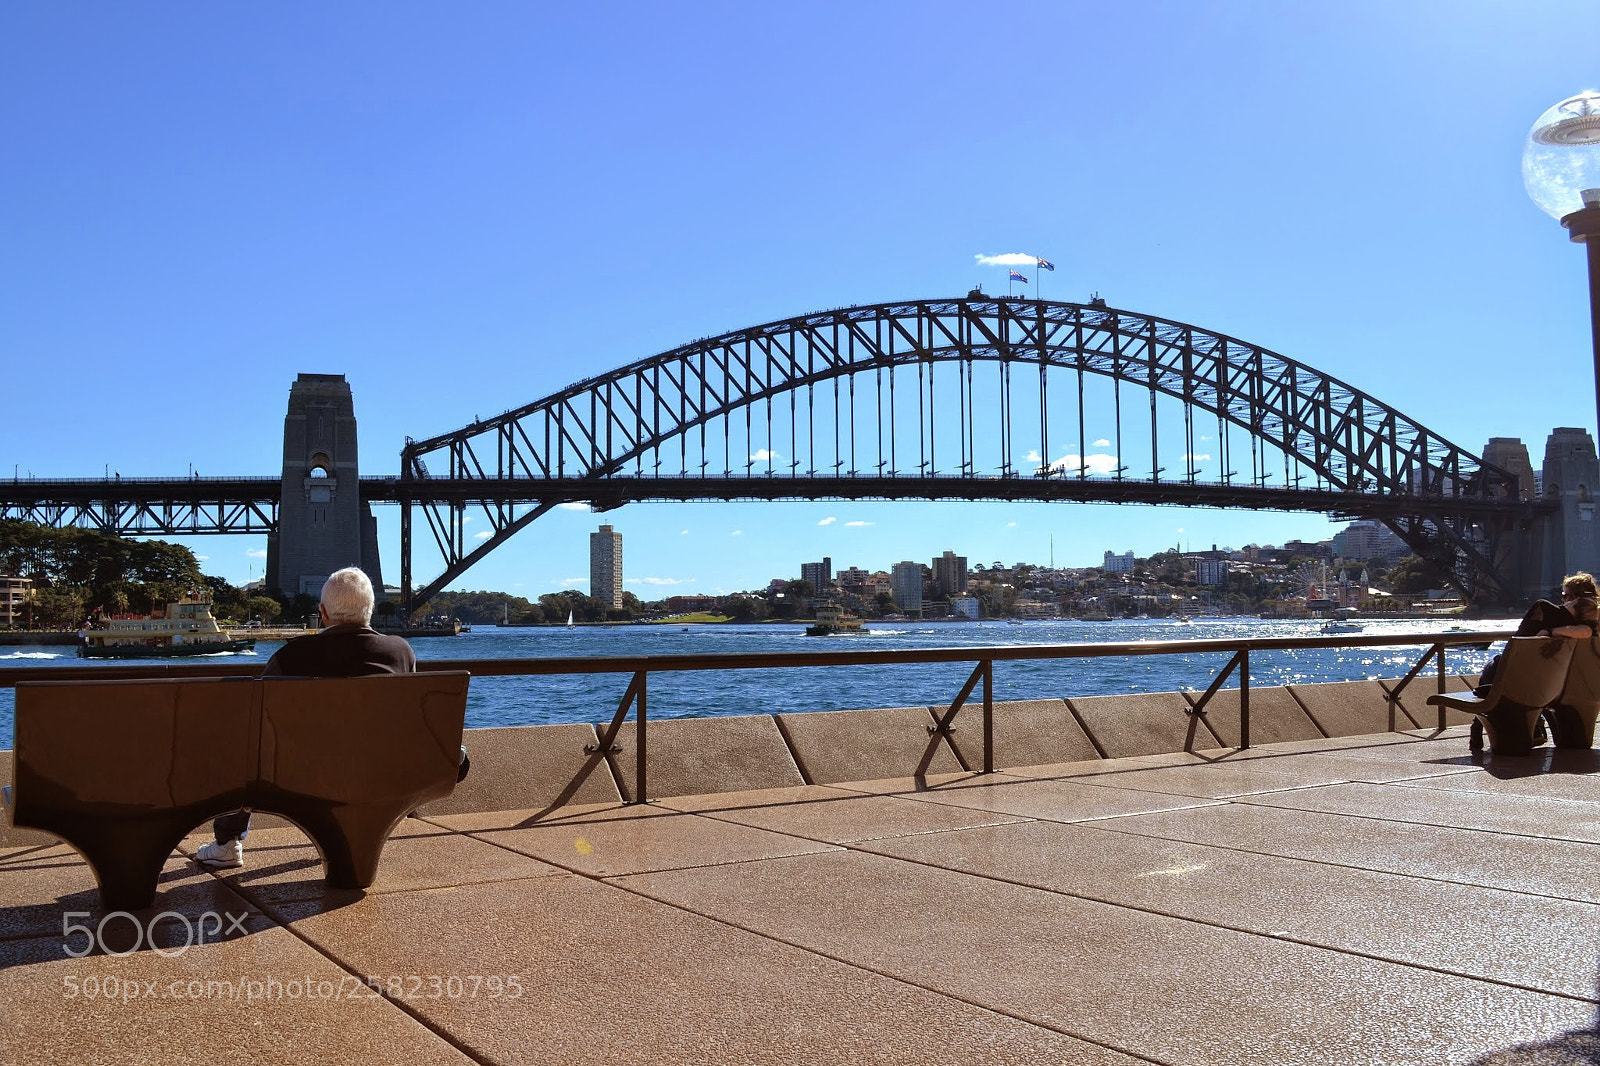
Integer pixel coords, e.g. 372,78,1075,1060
0,618,1514,749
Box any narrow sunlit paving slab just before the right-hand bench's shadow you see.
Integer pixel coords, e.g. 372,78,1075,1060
1237,783,1600,844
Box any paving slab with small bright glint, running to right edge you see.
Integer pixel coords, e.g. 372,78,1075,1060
861,820,1600,999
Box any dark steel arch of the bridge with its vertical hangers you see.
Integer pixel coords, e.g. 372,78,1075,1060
397,299,1544,603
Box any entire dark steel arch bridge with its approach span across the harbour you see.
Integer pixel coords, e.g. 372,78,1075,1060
0,290,1574,610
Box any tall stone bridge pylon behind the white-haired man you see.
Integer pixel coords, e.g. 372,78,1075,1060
267,375,384,597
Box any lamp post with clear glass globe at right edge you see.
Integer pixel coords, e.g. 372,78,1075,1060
1522,90,1600,432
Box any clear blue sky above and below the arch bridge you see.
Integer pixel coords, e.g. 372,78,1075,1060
0,0,1600,599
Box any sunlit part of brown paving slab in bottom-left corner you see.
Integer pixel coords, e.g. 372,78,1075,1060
0,919,472,1066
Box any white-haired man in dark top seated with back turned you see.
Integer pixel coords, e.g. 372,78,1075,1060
195,567,416,869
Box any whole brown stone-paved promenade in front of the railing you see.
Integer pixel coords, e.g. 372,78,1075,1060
0,728,1600,1066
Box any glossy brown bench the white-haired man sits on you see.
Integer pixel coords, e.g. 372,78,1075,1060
6,672,469,911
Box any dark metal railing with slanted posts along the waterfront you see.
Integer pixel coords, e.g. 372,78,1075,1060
0,631,1510,804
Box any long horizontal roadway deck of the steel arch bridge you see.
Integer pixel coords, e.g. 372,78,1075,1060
0,474,1557,535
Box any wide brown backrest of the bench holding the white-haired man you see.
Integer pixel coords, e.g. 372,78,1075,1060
14,672,469,821
